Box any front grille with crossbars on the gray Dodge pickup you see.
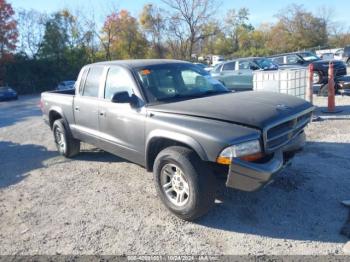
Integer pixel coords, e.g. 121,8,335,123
264,112,312,152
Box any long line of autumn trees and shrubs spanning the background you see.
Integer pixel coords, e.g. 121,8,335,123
0,0,350,93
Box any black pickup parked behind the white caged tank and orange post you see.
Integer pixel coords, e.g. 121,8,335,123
269,52,346,84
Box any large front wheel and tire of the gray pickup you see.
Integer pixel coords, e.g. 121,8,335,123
153,146,216,221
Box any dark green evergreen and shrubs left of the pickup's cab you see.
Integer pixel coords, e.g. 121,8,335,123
5,10,92,94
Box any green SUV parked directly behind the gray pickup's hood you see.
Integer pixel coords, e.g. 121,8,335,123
210,57,278,91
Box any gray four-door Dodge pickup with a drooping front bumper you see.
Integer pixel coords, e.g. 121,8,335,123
41,60,314,220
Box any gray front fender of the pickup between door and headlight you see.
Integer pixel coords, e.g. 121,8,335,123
146,112,261,162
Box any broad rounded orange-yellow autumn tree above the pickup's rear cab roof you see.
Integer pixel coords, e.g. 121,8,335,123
102,10,148,59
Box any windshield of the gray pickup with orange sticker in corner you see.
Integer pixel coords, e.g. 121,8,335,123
136,64,230,103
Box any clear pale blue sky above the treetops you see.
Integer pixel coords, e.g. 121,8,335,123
7,0,350,28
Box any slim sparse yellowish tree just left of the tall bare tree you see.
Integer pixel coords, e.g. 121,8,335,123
139,4,165,58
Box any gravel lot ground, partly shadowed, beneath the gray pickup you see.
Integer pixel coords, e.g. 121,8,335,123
0,93,350,255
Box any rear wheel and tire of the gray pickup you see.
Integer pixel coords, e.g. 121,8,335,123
52,119,80,158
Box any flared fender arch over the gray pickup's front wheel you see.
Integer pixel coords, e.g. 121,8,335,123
145,130,208,171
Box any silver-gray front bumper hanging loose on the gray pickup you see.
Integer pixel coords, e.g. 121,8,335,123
226,132,305,191
